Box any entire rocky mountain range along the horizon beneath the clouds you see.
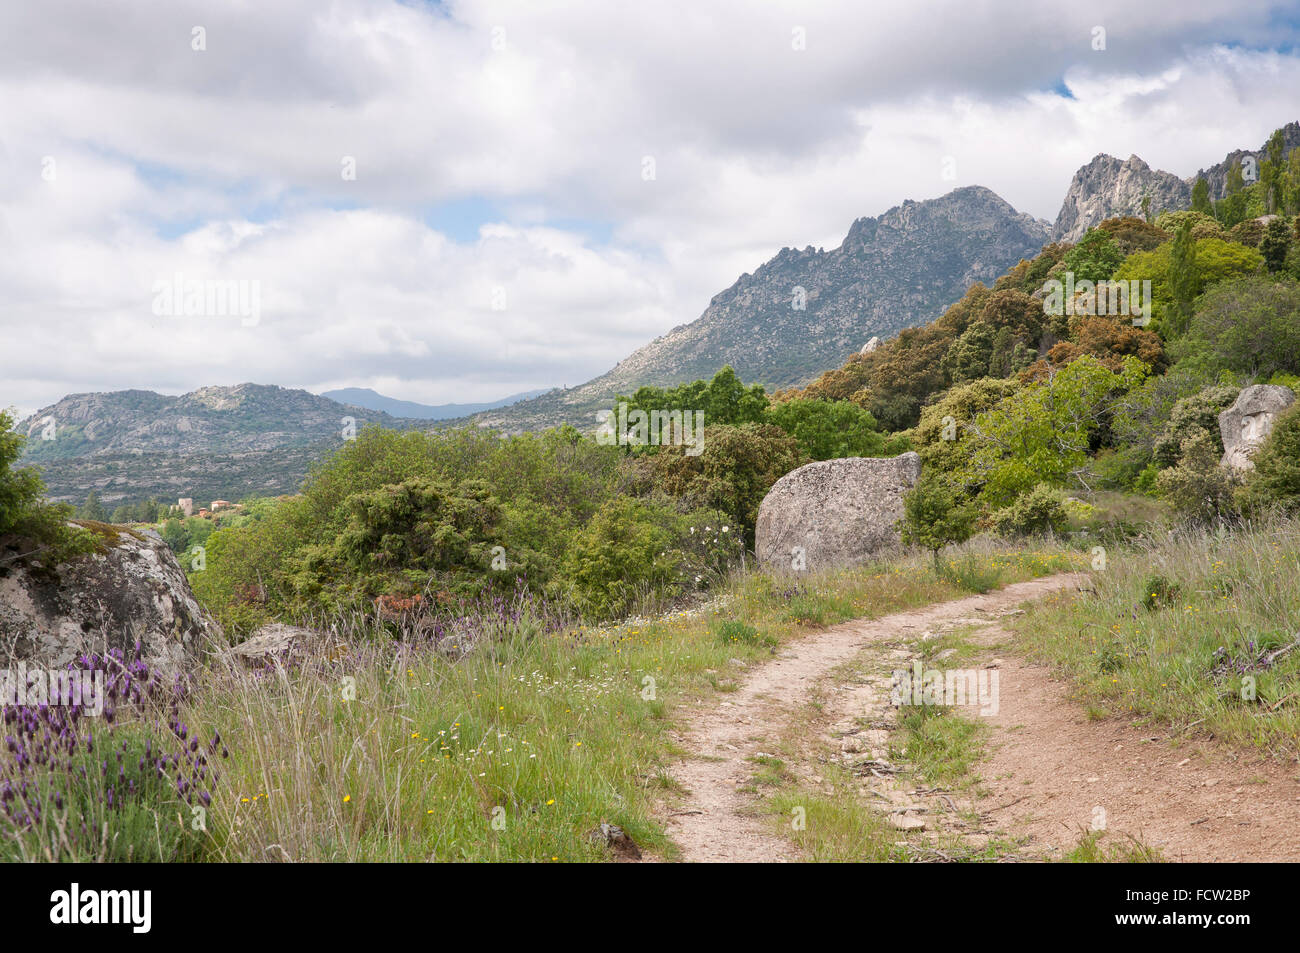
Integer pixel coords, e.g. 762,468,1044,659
20,122,1300,502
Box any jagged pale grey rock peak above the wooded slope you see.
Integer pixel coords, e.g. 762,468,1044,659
1052,155,1192,242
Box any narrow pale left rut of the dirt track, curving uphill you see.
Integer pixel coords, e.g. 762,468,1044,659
664,575,1078,862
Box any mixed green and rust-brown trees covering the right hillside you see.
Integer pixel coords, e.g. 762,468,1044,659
779,135,1300,545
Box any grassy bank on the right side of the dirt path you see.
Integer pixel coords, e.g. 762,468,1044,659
1011,520,1300,755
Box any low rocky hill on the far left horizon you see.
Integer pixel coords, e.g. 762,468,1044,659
18,384,428,503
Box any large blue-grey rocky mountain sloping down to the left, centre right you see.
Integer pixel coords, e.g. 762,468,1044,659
462,186,1049,430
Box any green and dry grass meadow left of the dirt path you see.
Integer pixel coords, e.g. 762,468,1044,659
139,538,1069,862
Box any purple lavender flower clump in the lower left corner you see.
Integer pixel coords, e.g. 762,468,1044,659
0,642,229,837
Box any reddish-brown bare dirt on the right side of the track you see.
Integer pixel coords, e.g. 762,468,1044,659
978,660,1300,861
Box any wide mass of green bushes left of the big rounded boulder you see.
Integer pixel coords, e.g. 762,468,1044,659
191,425,764,632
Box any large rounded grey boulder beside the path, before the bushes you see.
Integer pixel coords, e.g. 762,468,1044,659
755,452,920,571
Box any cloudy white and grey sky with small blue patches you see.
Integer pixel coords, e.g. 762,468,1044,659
0,0,1300,411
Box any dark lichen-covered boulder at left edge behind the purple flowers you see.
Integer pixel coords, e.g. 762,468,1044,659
0,523,221,672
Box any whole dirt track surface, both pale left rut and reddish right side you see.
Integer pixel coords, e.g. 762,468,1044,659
664,575,1300,862
